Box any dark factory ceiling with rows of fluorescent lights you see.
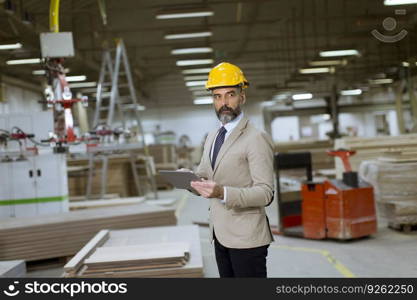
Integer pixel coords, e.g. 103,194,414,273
0,0,417,107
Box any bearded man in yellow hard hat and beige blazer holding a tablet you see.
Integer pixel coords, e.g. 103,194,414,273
191,63,273,277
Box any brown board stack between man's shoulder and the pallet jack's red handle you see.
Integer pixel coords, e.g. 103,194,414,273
275,140,334,170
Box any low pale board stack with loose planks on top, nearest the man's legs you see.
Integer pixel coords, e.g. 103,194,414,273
64,225,203,277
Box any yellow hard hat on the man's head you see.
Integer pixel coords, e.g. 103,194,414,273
206,62,249,90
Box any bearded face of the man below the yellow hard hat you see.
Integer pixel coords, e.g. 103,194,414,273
212,87,246,124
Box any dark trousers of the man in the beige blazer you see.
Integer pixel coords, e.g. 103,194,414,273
214,234,269,278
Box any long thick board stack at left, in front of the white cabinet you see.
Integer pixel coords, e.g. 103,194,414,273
0,203,176,261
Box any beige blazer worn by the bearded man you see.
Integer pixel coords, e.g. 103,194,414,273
196,116,274,249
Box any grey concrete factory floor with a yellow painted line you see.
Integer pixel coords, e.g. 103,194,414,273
28,190,417,277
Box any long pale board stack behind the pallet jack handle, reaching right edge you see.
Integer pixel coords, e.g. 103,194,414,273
334,134,417,178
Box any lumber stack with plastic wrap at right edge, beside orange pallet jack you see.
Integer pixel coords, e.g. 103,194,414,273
359,154,417,228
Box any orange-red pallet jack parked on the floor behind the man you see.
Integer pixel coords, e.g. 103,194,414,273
277,149,377,240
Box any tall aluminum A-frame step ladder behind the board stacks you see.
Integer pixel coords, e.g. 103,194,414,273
86,39,158,199
